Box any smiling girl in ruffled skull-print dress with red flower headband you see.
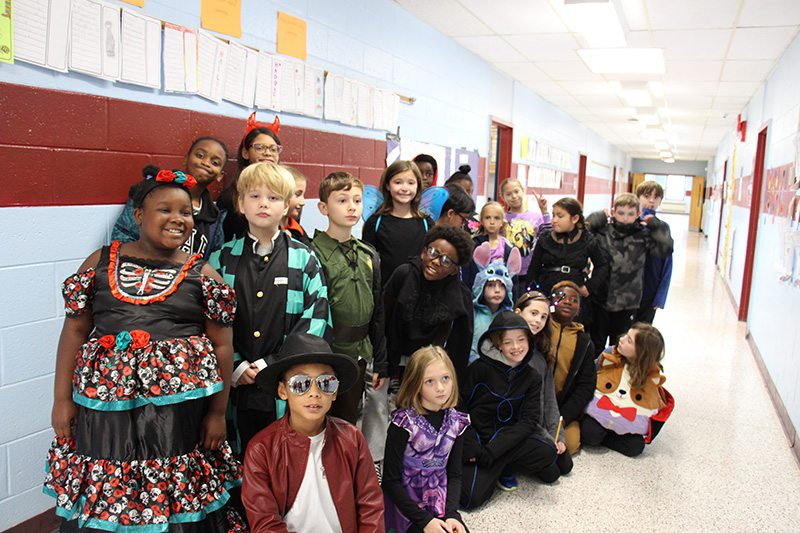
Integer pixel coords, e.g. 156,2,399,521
44,170,246,533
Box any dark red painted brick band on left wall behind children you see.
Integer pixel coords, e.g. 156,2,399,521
0,83,386,207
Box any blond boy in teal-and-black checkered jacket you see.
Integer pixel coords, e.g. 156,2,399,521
209,163,330,454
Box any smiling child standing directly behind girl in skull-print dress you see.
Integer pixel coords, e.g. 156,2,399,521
111,137,228,259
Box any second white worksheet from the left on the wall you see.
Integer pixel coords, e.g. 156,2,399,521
69,0,120,80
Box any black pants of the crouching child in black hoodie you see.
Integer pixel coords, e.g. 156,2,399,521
460,437,560,509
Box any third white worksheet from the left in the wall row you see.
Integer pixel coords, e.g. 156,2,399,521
120,8,161,89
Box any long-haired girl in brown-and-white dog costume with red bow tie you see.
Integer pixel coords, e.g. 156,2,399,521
581,322,675,457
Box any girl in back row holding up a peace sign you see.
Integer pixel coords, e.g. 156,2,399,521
500,178,551,272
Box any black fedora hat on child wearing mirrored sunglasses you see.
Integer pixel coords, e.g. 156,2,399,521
255,333,359,395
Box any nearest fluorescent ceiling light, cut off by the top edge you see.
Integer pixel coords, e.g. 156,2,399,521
563,0,628,48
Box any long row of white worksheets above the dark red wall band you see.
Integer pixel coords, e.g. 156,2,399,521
8,0,400,132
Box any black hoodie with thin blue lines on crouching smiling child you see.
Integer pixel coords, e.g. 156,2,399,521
461,311,542,461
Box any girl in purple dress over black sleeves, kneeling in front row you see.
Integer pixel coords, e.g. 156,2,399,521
383,346,469,533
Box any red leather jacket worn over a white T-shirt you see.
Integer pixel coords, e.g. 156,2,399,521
242,416,385,533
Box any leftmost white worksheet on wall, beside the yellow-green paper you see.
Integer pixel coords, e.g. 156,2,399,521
13,0,72,72
